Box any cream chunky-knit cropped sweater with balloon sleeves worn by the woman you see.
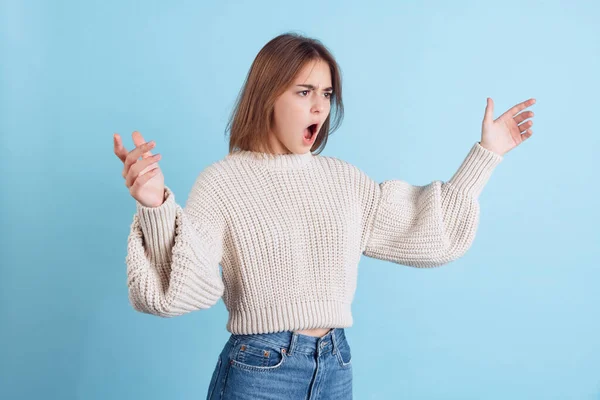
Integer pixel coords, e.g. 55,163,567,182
126,142,503,334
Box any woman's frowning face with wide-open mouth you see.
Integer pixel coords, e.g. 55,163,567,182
269,60,333,154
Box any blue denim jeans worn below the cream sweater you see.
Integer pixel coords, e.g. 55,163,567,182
206,328,352,400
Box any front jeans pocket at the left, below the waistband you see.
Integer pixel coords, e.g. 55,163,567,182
231,339,286,372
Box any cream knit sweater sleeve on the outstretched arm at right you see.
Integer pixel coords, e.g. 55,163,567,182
361,142,503,268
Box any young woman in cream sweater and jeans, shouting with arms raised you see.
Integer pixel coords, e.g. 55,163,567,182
114,33,534,400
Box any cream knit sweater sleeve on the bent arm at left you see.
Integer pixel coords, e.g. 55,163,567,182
126,173,224,317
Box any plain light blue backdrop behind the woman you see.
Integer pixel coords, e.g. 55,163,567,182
0,0,600,400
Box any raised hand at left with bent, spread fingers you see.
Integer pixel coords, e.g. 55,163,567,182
113,131,165,207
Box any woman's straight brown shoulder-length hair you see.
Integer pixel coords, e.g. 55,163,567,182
226,32,344,154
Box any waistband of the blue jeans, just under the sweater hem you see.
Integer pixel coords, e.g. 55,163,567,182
229,328,346,356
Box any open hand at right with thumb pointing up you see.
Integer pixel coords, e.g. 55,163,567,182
479,97,535,156
